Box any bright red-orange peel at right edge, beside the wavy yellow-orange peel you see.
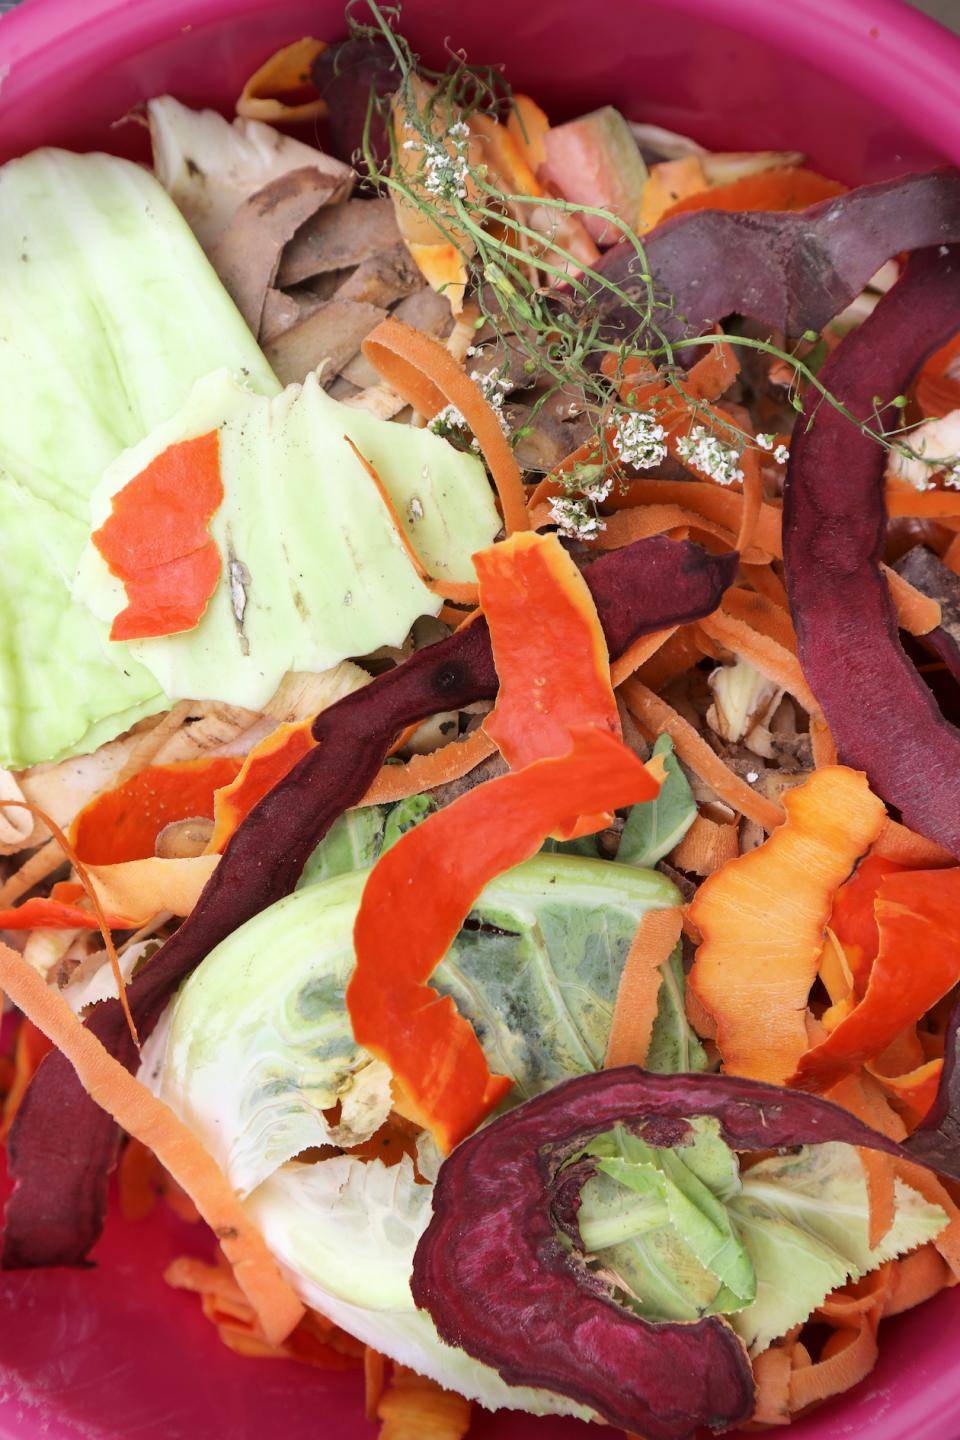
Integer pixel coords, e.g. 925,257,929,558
790,861,960,1092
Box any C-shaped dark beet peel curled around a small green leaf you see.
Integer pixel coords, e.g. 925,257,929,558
412,1066,904,1440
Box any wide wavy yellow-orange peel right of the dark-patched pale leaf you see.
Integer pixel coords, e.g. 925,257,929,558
689,766,884,1084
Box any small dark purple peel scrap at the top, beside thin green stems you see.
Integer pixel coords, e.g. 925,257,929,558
312,37,400,171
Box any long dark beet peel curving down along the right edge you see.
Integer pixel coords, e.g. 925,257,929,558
783,246,960,857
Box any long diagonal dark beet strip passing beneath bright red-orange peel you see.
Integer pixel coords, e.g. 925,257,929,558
1,536,738,1269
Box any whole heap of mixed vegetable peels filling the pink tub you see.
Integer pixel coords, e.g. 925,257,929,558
0,19,960,1440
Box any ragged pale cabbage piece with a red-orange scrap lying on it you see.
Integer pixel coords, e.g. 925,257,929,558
75,370,499,710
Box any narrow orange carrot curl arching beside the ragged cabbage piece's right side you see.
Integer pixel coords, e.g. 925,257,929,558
361,320,530,534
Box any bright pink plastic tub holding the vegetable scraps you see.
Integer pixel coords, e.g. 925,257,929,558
0,0,960,1440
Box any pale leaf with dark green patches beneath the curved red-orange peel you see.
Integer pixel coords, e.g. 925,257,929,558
158,855,676,1194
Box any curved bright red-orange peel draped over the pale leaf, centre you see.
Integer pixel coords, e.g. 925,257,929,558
347,729,658,1152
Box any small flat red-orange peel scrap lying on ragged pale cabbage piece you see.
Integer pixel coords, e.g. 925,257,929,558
92,431,223,639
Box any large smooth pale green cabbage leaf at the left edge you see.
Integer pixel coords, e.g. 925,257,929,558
0,150,279,769
